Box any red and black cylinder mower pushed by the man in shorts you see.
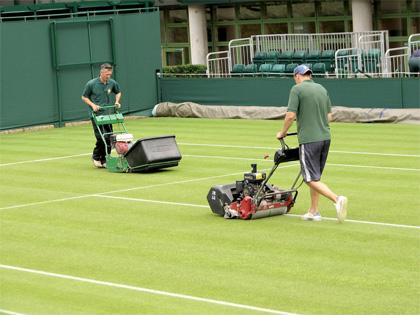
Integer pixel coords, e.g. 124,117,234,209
207,133,300,220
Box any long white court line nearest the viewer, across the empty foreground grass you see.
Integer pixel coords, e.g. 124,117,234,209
0,264,297,315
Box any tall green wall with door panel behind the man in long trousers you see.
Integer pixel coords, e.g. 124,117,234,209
0,9,162,129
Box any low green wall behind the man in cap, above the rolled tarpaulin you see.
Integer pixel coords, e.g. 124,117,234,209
160,77,420,108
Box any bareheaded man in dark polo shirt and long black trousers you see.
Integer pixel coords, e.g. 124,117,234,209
82,63,121,168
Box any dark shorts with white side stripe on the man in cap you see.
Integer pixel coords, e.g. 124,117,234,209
299,140,331,183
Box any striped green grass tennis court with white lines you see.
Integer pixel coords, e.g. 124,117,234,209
0,118,420,315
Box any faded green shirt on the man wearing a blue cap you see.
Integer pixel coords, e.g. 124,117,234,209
287,80,331,144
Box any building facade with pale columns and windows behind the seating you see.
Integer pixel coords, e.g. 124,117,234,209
1,0,420,66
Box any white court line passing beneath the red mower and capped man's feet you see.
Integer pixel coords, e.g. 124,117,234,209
95,194,420,229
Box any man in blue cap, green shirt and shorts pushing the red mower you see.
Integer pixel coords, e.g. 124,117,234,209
277,65,347,222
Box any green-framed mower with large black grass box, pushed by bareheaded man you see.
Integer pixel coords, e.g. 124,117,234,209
92,105,181,173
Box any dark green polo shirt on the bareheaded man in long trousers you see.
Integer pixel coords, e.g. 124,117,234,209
83,77,121,112
